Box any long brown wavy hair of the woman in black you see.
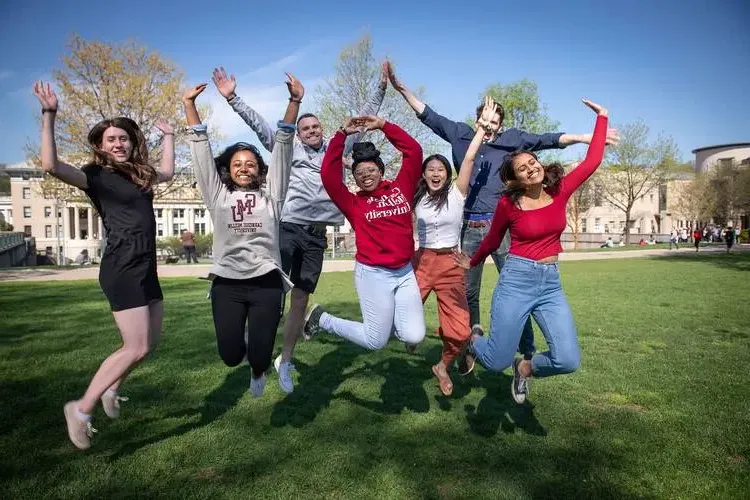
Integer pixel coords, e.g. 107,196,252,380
88,116,156,191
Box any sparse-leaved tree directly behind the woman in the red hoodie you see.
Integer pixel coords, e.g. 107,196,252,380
314,35,437,177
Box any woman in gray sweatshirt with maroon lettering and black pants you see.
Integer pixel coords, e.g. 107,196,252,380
182,74,304,398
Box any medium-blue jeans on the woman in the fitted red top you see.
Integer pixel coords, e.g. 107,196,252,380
472,255,581,377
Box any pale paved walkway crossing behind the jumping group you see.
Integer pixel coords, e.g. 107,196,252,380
0,245,750,281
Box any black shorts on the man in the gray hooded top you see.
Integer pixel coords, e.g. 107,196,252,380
279,222,328,293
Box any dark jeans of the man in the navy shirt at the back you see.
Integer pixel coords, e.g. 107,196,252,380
461,220,536,358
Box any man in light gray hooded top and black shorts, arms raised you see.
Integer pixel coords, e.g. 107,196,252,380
213,63,387,393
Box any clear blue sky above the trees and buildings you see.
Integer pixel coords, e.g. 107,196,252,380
0,0,750,164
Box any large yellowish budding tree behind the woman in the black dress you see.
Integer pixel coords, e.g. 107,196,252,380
26,36,210,203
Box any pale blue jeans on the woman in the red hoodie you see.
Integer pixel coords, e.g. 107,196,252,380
320,262,425,350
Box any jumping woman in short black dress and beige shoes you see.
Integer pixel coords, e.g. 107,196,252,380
34,82,174,449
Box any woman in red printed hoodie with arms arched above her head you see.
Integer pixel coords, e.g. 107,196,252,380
304,116,425,350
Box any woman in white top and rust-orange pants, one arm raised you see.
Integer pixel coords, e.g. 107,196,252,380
407,98,497,396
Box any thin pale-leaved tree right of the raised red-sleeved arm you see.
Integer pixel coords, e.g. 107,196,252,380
597,121,679,243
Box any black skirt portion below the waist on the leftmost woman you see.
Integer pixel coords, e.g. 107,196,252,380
99,245,164,311
